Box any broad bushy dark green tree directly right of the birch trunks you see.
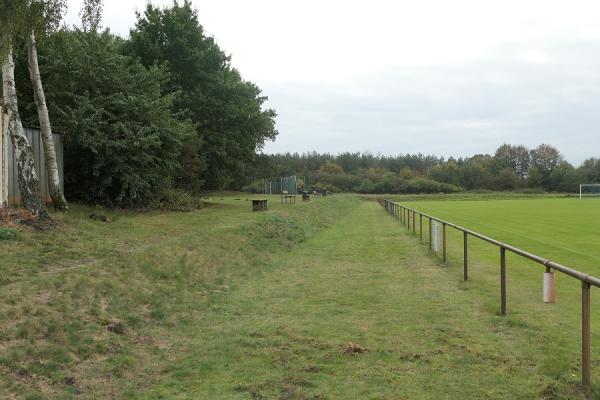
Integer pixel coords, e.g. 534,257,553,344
16,30,201,207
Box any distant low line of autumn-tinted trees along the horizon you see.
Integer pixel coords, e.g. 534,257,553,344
245,144,600,193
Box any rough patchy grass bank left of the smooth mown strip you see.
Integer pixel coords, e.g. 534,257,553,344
0,196,357,398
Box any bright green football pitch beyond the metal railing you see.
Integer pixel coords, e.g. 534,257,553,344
402,198,600,276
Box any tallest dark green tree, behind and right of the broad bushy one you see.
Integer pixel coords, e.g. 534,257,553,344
126,0,277,189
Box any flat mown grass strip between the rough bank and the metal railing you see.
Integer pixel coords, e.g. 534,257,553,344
139,201,581,399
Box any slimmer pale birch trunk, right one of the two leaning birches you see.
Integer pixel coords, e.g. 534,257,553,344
27,31,68,211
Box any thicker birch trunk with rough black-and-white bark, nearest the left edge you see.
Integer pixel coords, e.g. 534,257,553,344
2,52,50,222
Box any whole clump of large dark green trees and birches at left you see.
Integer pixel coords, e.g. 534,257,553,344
0,0,277,220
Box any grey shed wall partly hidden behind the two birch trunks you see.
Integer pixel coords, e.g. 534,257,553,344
0,99,64,206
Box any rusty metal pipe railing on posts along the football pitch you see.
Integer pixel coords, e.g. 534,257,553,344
378,198,600,386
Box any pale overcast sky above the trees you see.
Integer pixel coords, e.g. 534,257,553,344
67,0,600,164
